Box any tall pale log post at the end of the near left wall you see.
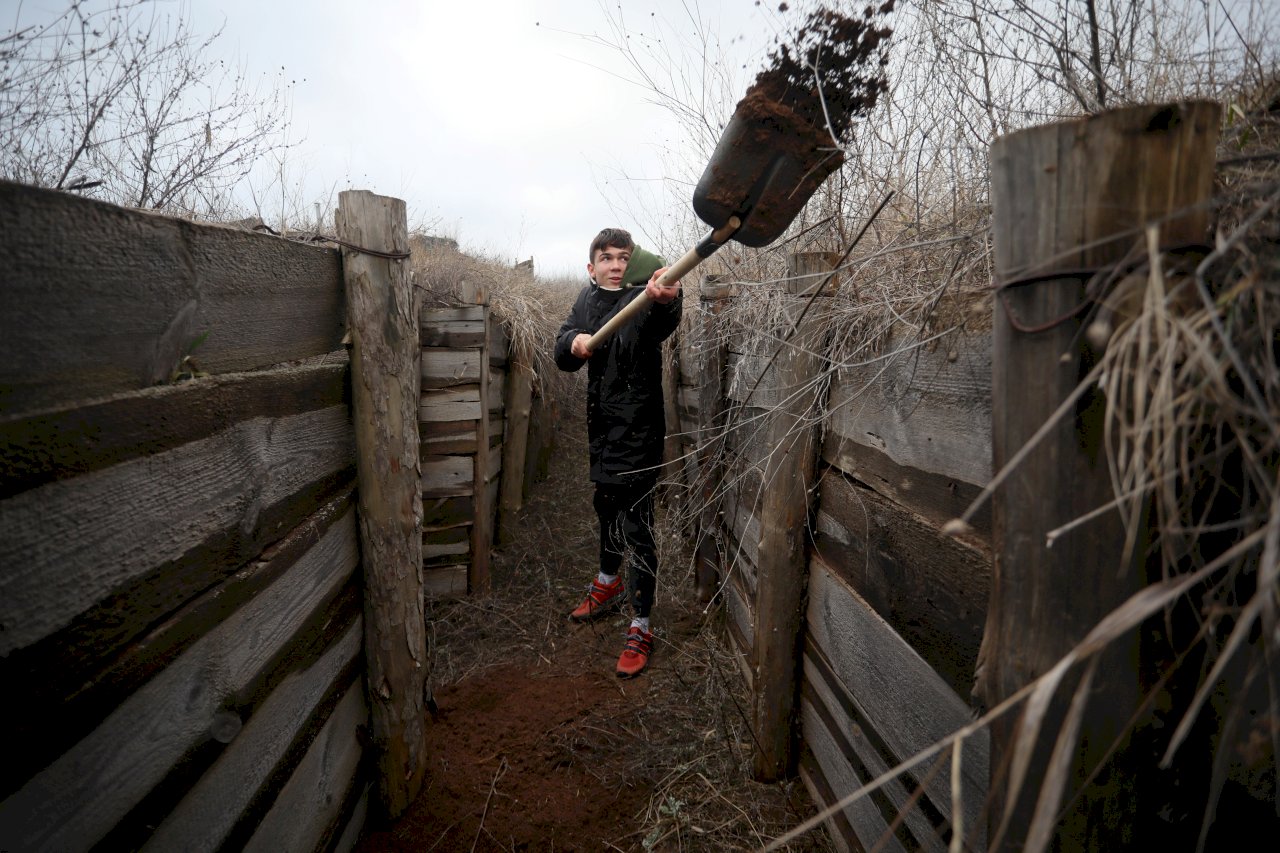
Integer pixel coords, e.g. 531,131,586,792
335,191,428,817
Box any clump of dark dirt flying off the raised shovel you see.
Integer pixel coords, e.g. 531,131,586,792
737,0,895,143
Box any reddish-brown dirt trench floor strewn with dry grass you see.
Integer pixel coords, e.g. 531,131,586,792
357,394,832,853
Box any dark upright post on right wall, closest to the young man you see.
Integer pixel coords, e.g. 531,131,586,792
690,274,733,602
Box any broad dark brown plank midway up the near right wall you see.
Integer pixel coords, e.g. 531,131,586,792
814,470,992,695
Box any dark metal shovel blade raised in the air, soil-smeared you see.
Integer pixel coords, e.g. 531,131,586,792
694,100,845,247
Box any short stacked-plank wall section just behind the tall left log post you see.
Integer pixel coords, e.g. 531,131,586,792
419,304,509,598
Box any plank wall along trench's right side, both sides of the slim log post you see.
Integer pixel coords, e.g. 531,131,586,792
677,275,992,850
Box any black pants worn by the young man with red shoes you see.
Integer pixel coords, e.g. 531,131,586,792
594,482,658,617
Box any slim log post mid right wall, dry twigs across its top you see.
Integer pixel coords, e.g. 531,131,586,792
751,252,835,781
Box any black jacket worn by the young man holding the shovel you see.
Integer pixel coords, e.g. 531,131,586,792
556,282,681,485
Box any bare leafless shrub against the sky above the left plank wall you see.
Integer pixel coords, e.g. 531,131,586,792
0,0,291,215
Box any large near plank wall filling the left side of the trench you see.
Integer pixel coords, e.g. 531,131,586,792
0,182,369,850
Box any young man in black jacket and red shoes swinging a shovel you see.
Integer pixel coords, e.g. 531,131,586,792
556,228,681,678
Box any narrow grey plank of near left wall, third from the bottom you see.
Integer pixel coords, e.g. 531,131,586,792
142,619,364,852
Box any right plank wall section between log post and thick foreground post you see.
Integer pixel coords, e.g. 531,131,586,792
801,313,992,850
